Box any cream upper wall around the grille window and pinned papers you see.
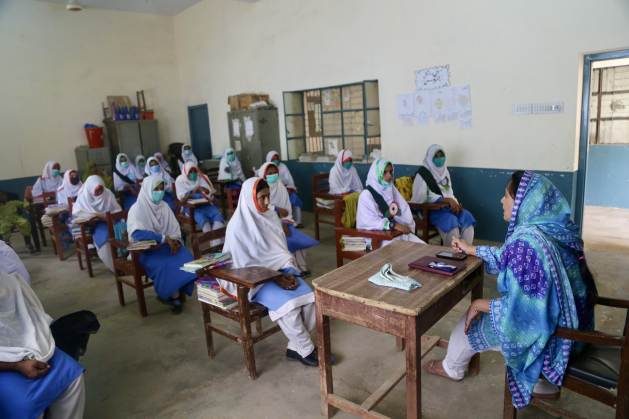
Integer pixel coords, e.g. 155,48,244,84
174,0,629,171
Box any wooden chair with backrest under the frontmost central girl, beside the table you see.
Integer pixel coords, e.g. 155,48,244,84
192,233,280,380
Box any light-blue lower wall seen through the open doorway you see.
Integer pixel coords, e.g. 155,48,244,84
585,144,629,208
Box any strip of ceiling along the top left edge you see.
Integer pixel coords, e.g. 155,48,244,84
38,0,201,16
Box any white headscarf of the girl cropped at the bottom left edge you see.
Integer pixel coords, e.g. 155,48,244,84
0,272,55,362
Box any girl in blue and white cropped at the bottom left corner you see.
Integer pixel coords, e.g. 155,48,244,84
0,272,85,419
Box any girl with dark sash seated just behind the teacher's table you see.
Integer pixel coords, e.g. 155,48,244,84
356,159,424,246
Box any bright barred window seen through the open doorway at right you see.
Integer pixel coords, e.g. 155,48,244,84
589,65,629,144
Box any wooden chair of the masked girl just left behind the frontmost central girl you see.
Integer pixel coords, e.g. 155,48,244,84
107,211,153,317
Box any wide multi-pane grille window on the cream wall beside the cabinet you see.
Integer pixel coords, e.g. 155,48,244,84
284,80,380,160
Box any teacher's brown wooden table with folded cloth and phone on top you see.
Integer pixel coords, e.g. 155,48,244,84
313,241,483,418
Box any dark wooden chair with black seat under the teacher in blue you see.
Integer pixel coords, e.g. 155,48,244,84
503,287,629,419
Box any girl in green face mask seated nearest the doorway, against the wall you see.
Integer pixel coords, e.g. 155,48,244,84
410,144,476,246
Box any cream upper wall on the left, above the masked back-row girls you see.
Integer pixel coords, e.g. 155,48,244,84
0,0,188,179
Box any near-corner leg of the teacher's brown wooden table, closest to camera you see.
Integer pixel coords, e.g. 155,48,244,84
405,316,422,418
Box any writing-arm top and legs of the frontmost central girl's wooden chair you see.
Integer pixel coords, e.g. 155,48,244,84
197,266,281,380
